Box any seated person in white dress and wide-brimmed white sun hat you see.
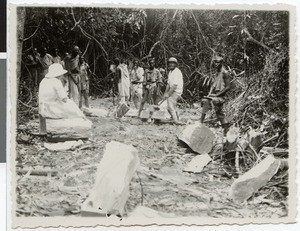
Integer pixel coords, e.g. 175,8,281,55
39,63,85,135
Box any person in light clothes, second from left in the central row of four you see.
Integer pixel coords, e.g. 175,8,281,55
130,60,144,109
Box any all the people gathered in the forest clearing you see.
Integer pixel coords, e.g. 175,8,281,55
31,43,230,134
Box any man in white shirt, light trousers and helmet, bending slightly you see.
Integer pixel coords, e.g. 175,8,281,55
164,57,183,124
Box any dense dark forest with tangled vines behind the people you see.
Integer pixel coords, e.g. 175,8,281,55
17,7,289,147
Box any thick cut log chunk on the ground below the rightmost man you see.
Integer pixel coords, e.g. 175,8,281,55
178,123,215,154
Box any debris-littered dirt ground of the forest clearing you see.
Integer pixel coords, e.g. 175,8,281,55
16,99,287,218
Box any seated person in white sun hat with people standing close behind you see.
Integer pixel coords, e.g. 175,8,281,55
28,46,90,135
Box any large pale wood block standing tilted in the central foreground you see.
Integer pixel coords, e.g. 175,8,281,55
81,141,139,216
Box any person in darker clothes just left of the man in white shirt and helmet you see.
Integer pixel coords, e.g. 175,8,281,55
139,58,162,116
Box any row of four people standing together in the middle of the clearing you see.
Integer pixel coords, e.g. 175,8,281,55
111,57,183,123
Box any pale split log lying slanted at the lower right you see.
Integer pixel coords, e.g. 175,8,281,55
229,155,281,202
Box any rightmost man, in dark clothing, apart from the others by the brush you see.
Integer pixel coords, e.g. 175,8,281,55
200,56,230,135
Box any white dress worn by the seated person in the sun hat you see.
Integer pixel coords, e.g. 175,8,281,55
39,78,85,119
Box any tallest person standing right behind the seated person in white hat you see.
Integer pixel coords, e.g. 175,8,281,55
65,46,81,105
